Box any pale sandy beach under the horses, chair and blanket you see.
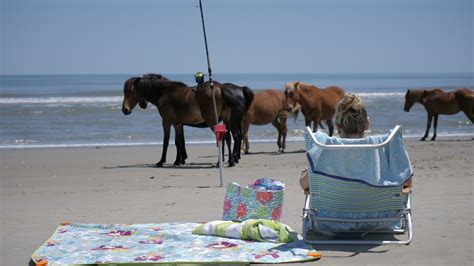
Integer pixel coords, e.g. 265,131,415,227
0,137,474,265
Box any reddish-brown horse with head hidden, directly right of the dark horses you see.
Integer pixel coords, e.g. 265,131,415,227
242,89,288,154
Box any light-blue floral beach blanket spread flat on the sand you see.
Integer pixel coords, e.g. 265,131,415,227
32,223,319,265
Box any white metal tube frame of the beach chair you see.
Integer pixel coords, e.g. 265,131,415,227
303,125,413,245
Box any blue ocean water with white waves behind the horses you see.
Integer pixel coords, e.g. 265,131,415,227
0,73,474,149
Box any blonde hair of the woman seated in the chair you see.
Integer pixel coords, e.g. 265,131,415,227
336,93,369,137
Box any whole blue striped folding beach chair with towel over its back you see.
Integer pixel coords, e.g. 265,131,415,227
303,126,413,245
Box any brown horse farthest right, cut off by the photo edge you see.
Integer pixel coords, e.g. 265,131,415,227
404,89,474,141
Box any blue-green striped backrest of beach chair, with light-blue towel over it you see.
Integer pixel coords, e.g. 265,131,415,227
305,127,412,213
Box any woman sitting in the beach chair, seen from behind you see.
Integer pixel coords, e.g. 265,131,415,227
300,93,412,195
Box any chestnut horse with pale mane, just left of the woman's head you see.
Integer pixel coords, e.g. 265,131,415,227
285,81,345,136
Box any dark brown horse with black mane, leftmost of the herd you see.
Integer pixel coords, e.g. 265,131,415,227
122,74,256,167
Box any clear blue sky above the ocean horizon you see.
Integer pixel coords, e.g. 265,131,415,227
0,0,474,74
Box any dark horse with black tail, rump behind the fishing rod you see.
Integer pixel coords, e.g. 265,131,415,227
196,81,254,163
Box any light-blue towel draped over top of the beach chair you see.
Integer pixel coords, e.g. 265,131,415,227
307,131,413,186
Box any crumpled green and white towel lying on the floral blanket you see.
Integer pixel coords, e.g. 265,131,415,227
192,219,294,243
